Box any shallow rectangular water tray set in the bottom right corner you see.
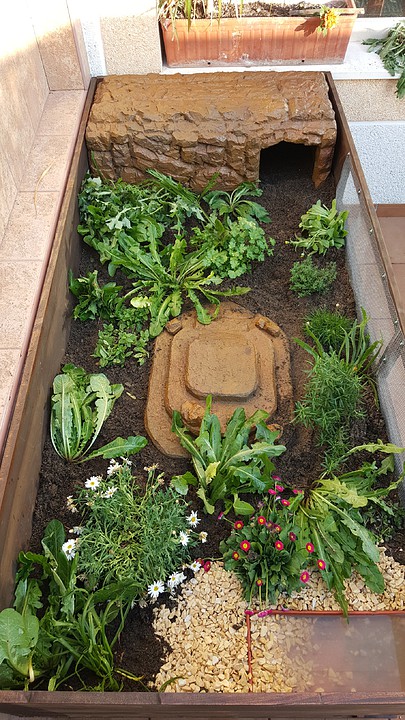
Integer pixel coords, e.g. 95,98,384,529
251,615,405,693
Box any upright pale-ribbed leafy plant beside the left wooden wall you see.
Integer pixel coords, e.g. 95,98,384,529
50,364,147,462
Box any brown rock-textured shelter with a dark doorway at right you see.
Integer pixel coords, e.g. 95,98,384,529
86,72,336,191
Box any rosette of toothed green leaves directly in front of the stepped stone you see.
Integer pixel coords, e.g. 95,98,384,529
172,396,285,515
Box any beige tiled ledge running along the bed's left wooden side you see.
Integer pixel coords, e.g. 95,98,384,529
0,90,85,447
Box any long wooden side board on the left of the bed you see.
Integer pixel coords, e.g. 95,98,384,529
0,83,96,608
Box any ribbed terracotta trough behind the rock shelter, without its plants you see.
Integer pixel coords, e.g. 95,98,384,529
161,0,359,67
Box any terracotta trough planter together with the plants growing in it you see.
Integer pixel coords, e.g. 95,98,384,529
158,0,359,67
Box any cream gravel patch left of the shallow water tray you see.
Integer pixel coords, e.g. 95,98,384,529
154,563,249,692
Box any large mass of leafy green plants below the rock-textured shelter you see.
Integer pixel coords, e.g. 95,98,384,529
75,170,274,365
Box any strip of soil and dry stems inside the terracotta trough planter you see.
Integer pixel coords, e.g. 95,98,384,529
177,0,346,20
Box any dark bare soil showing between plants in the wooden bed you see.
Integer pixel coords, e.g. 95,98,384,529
31,143,405,690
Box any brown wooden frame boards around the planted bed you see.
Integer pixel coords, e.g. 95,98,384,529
0,76,405,720
